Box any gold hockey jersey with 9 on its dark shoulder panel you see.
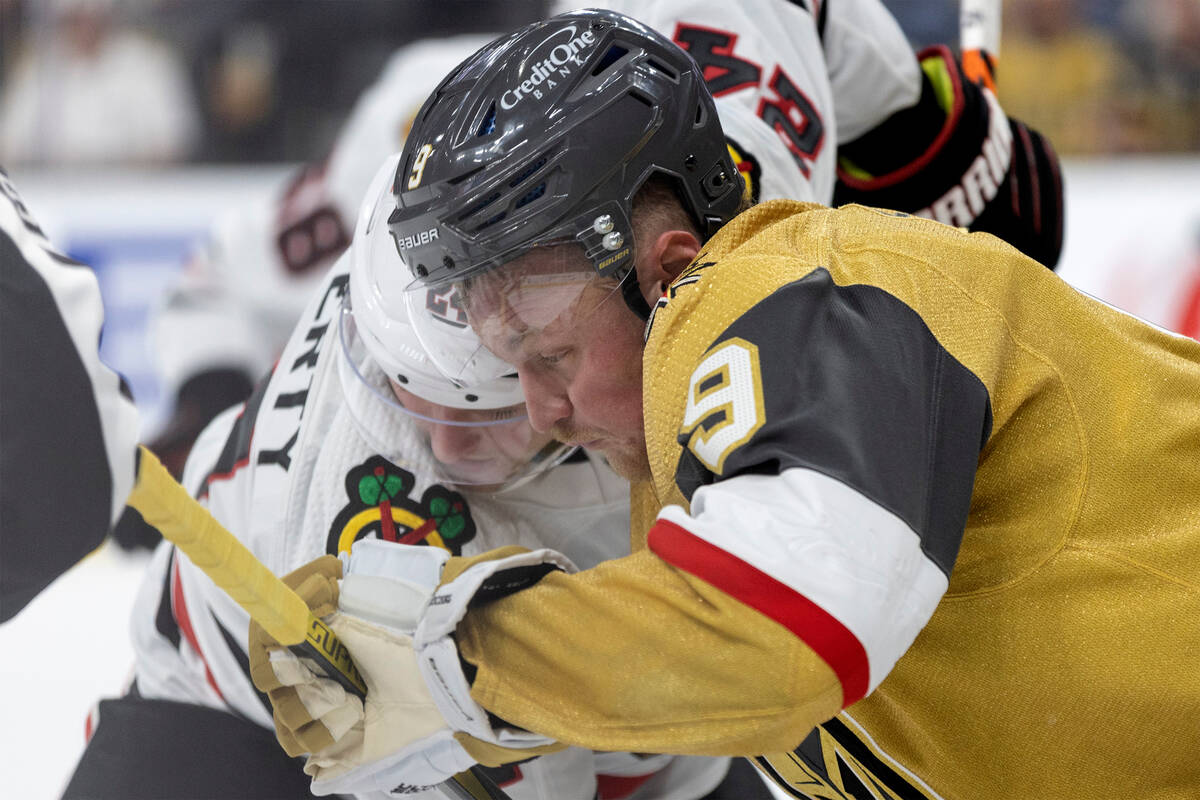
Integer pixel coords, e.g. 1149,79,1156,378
458,201,1200,800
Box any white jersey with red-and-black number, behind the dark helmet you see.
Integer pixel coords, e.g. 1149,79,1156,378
552,0,922,205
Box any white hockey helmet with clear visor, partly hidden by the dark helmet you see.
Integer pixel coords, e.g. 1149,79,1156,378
338,155,575,491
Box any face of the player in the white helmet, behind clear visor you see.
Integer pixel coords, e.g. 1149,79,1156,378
391,381,551,487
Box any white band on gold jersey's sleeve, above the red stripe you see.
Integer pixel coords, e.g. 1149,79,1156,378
652,468,948,702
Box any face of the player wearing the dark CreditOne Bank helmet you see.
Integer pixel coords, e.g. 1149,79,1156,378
468,257,649,480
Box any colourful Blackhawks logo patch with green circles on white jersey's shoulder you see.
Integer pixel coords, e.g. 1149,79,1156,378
325,456,475,555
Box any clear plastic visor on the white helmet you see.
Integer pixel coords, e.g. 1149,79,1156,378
338,301,574,491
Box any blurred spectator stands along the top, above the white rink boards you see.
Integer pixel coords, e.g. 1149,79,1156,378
0,0,1200,168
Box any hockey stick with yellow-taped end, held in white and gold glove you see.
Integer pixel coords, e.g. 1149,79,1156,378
126,447,510,800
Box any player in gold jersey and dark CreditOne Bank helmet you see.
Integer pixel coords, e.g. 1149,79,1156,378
248,6,1200,800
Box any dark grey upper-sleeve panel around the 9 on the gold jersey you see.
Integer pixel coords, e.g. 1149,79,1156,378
677,269,991,575
